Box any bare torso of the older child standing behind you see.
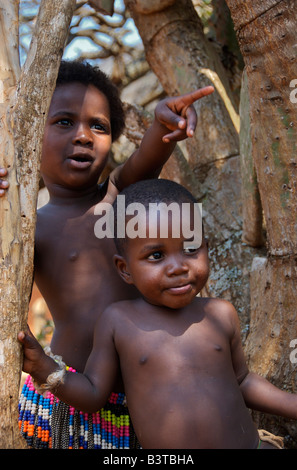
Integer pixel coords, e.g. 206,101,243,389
35,192,136,371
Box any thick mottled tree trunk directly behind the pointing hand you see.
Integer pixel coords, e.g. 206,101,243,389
125,0,257,329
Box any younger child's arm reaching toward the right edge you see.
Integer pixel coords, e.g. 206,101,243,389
230,306,297,419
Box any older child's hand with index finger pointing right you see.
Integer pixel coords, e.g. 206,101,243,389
155,86,214,143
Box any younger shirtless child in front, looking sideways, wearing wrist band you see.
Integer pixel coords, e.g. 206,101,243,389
19,180,297,449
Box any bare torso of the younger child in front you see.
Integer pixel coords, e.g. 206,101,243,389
107,299,258,449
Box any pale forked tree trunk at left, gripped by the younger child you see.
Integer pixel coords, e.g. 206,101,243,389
0,0,75,448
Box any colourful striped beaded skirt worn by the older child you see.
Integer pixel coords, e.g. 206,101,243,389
19,367,135,449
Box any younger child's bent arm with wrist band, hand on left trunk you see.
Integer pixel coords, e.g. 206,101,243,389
18,312,119,413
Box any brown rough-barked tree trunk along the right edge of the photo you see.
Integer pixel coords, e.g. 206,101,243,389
227,0,297,446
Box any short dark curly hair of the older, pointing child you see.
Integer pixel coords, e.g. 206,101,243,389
56,60,125,141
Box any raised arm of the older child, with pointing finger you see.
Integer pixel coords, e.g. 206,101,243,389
111,86,214,191
